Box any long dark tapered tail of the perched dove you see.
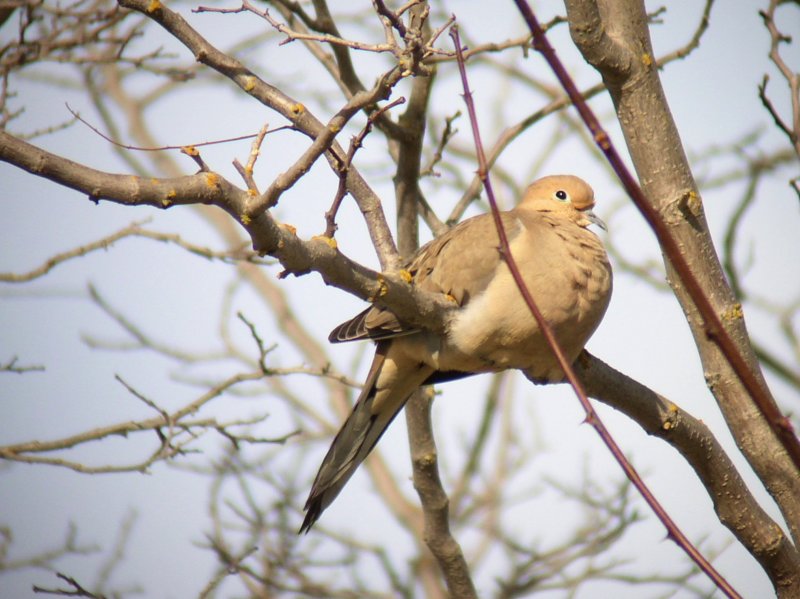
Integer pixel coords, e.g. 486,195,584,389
298,342,407,533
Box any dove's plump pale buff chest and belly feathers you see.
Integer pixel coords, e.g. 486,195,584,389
448,214,611,369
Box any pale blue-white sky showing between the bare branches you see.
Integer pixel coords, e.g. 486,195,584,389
0,1,800,599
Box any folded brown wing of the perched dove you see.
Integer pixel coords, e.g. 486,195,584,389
328,211,522,343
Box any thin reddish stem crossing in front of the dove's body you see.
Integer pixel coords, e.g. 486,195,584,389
450,25,740,598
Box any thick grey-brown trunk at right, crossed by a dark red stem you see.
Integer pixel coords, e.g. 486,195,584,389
567,0,800,552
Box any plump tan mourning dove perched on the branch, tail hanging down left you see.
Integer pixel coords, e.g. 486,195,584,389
300,175,611,532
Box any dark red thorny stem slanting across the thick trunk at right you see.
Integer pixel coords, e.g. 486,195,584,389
514,0,800,476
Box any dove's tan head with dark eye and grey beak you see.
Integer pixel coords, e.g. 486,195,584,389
519,175,606,229
